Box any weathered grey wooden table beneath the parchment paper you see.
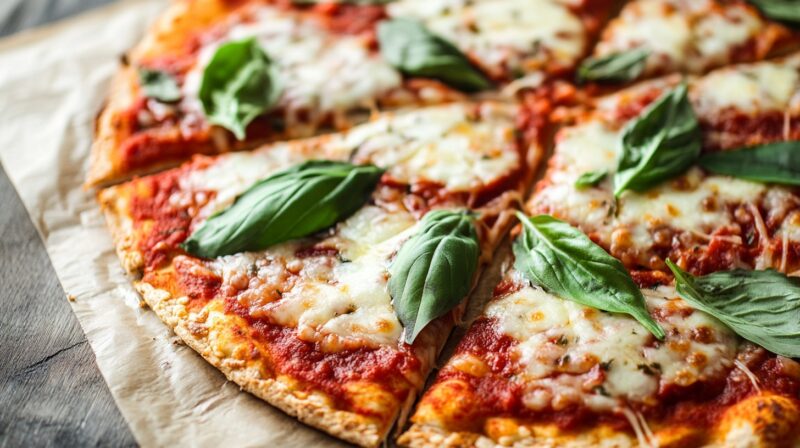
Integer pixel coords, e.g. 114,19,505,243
0,0,136,447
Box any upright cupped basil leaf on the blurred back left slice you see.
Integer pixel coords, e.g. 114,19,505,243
200,39,281,140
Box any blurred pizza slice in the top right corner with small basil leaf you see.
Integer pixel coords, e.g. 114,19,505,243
579,0,800,82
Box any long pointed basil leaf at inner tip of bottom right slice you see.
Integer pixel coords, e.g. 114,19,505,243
513,212,665,339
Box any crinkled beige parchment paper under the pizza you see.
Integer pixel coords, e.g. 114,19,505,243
0,0,350,447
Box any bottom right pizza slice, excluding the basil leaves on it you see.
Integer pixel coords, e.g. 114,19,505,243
399,254,800,448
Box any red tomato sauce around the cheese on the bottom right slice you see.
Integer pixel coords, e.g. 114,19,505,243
428,296,800,431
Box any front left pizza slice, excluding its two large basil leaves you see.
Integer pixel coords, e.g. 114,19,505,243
99,103,541,446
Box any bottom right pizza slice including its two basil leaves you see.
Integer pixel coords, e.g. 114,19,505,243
399,219,800,448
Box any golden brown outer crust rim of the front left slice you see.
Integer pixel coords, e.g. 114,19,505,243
98,185,477,447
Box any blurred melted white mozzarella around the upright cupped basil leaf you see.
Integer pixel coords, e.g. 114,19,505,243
183,6,402,119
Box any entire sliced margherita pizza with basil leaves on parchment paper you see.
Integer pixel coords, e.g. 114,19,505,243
86,0,800,448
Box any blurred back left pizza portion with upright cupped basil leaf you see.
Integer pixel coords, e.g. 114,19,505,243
86,0,608,186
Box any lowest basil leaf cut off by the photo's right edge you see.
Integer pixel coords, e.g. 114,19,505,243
667,260,800,358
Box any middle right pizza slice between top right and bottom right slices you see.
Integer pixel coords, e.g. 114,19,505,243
527,55,800,284
